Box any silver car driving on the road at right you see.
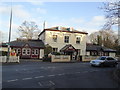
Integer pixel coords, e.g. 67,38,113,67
90,56,118,67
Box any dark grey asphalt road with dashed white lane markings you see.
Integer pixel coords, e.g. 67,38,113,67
0,61,119,89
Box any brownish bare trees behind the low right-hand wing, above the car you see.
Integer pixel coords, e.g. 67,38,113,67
89,30,117,49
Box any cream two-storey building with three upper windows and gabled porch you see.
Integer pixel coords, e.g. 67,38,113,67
39,27,88,60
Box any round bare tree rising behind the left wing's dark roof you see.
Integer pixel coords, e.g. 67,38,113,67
18,21,40,39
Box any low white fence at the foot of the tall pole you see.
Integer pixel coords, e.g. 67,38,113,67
0,56,20,63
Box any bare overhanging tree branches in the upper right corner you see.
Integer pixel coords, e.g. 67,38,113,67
102,0,120,45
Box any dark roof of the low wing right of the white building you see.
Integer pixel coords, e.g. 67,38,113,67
86,44,116,52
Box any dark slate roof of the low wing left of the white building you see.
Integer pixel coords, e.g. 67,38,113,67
2,40,44,48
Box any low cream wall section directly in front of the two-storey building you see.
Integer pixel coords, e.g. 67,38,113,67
51,55,70,62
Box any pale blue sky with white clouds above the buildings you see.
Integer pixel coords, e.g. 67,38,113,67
0,2,117,42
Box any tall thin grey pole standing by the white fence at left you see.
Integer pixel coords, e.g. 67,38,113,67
6,8,12,62
